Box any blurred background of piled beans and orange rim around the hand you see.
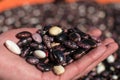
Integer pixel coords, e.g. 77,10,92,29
0,0,120,80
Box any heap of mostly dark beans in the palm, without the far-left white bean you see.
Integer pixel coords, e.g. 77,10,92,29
14,26,100,75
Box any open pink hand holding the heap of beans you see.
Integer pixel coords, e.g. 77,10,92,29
0,28,118,80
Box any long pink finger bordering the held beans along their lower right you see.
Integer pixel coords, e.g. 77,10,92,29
61,45,106,80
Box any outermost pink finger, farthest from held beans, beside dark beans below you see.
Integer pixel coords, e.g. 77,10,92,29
79,42,118,77
